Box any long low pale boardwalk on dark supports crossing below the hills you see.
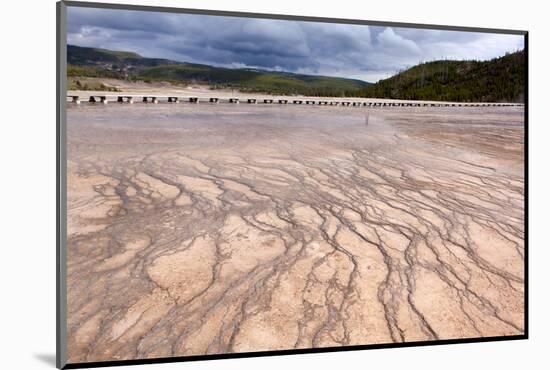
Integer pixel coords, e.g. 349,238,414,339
67,94,523,107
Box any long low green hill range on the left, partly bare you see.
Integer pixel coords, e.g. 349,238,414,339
67,45,369,96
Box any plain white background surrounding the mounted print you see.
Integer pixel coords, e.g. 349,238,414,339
0,0,550,370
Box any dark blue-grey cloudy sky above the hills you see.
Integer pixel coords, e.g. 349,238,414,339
67,7,523,82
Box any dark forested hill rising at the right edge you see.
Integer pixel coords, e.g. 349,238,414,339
356,51,525,102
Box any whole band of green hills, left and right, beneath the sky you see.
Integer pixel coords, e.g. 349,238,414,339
67,45,525,102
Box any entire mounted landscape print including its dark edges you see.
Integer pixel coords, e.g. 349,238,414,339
57,1,527,368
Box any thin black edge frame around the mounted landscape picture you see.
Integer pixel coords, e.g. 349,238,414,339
56,1,529,369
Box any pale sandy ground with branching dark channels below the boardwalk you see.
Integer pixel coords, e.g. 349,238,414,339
68,104,525,363
